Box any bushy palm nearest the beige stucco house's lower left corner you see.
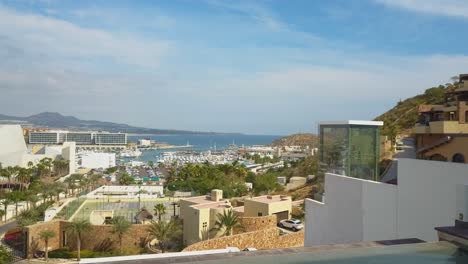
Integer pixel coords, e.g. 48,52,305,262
148,220,180,253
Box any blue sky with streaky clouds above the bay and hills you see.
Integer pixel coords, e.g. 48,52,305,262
0,0,468,134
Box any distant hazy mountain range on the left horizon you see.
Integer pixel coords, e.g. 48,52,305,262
0,112,234,135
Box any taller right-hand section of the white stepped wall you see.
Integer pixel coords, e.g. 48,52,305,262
397,159,468,241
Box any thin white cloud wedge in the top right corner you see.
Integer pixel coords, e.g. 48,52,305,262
375,0,468,18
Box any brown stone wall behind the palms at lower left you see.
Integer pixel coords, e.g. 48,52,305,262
27,220,149,254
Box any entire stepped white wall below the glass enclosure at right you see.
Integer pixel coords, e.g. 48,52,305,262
305,159,468,246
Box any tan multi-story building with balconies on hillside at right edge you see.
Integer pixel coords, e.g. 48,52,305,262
413,74,468,163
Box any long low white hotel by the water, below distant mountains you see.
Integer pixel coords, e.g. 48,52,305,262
29,131,127,145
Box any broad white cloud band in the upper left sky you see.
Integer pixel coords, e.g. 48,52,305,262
0,6,170,67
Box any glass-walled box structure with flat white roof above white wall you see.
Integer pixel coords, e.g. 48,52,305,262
320,120,383,181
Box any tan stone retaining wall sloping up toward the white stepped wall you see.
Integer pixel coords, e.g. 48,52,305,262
183,227,304,251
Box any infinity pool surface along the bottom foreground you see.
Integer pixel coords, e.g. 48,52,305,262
86,242,468,264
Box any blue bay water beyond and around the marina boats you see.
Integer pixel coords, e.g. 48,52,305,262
128,134,282,162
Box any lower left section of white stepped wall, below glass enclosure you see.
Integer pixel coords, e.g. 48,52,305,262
305,174,396,246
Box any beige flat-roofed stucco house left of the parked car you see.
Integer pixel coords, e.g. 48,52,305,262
179,190,292,245
